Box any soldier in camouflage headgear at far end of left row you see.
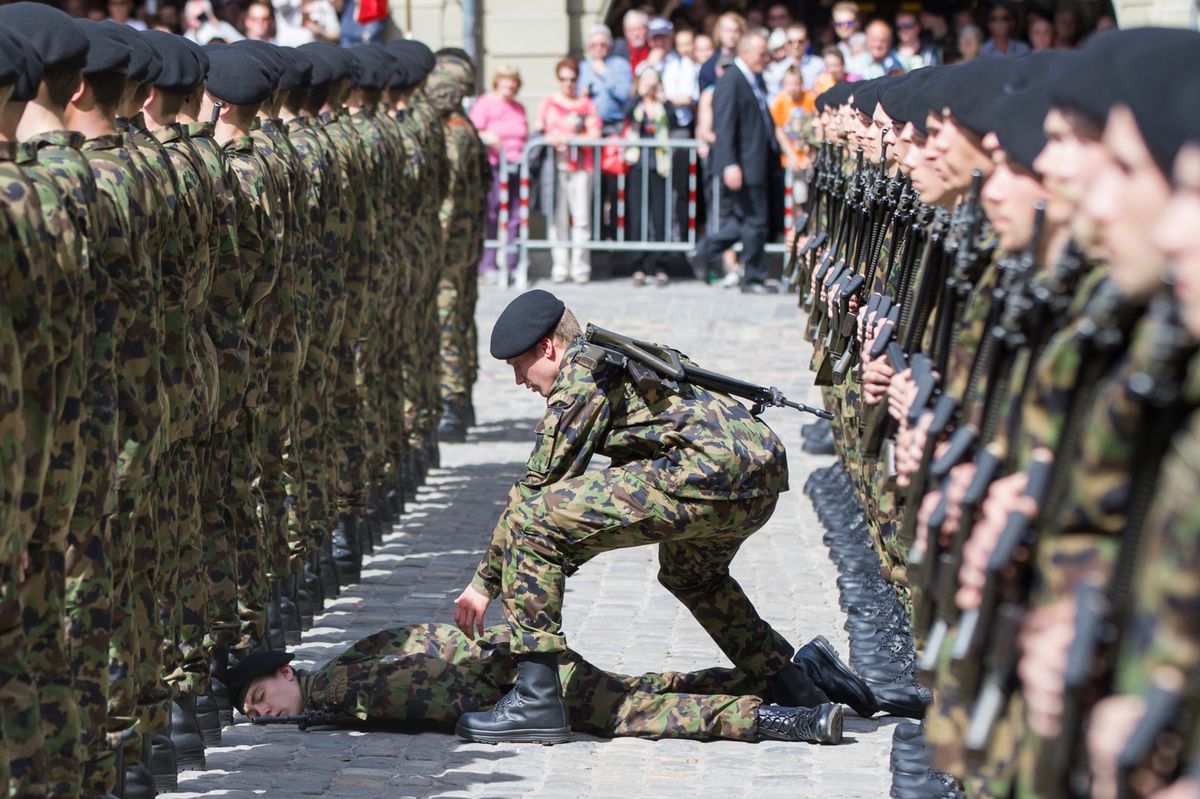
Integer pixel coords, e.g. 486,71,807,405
425,52,491,441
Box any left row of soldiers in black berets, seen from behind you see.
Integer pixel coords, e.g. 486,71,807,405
0,2,490,798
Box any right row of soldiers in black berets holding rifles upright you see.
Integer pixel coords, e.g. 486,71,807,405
785,29,1200,799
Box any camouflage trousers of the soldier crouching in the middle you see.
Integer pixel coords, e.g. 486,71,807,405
497,468,793,677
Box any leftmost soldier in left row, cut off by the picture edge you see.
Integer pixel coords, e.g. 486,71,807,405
0,31,56,792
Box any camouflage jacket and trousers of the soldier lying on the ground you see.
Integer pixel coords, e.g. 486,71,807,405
308,624,766,740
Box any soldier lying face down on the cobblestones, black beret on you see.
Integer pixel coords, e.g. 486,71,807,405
229,624,842,744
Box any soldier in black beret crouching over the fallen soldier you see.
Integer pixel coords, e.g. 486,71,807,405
455,290,875,743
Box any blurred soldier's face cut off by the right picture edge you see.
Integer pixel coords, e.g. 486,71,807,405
1154,144,1200,337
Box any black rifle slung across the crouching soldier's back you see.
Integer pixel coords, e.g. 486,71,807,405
583,324,833,419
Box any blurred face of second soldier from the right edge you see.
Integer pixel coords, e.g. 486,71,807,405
1082,106,1170,299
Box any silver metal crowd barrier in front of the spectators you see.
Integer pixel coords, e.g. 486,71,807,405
485,136,804,289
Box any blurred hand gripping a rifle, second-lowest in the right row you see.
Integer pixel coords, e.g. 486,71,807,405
1016,599,1075,738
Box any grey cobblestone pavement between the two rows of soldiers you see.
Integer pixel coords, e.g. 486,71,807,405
162,281,896,799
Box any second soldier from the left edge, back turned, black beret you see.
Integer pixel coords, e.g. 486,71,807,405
0,4,111,797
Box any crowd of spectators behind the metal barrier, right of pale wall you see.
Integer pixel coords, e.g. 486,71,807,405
470,0,1114,286
